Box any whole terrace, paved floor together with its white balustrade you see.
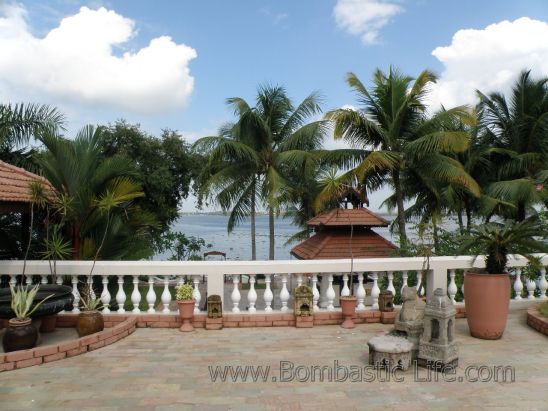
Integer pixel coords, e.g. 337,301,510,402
0,256,548,410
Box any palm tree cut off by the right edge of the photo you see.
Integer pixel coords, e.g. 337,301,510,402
477,71,548,221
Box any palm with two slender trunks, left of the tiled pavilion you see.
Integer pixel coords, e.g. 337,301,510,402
196,86,326,260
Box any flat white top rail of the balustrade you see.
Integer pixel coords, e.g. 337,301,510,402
0,254,548,276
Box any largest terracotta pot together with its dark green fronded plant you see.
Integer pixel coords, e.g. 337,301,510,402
460,218,548,340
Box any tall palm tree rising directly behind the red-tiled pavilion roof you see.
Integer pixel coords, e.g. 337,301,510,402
327,67,480,244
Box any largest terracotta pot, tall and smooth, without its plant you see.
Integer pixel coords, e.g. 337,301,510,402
464,273,510,340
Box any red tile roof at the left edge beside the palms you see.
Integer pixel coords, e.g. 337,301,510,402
0,161,55,203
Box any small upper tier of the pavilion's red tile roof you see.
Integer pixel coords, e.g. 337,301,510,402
307,208,389,227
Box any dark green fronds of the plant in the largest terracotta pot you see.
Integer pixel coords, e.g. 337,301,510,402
459,217,548,274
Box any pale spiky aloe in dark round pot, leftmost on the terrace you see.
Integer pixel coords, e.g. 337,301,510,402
2,285,51,352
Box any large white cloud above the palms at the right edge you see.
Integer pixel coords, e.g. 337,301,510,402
431,17,548,107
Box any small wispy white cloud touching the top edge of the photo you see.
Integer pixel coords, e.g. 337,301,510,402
333,0,403,45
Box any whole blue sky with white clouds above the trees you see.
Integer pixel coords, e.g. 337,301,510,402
0,0,548,211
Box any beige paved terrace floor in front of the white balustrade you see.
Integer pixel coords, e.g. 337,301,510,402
0,310,548,411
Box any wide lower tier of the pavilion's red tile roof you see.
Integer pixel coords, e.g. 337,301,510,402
291,229,397,260
